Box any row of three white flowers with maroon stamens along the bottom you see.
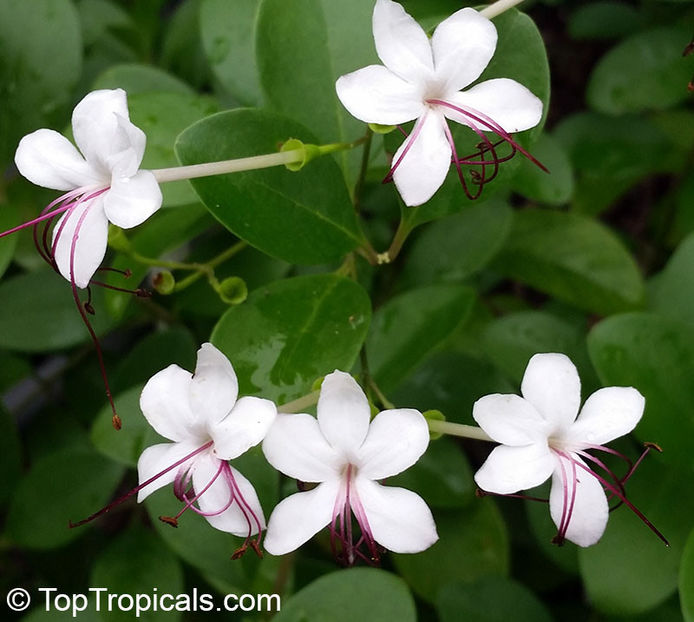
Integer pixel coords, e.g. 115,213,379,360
73,343,667,566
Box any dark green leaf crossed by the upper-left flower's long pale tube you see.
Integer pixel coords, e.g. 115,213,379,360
176,109,363,264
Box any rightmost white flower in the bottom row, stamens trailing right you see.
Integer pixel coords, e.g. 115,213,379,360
472,354,667,546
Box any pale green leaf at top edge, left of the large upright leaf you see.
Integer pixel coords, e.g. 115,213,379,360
200,0,262,106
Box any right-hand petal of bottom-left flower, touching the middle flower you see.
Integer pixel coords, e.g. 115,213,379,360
210,397,277,460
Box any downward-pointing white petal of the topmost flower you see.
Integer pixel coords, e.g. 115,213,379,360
393,110,451,207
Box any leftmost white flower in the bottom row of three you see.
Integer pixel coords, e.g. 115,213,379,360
137,343,277,553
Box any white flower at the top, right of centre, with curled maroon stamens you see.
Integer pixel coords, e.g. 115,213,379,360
336,0,542,205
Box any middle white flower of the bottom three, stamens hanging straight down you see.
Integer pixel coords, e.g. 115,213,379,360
263,371,438,565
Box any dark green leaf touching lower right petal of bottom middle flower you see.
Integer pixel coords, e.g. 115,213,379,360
392,499,509,603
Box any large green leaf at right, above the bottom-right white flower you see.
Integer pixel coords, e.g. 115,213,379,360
496,210,644,314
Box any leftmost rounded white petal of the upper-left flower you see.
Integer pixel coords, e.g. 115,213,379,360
14,130,103,190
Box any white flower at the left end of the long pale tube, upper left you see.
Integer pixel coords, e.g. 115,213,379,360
11,89,162,288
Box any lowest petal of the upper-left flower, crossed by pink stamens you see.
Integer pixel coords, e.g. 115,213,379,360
53,195,108,288
